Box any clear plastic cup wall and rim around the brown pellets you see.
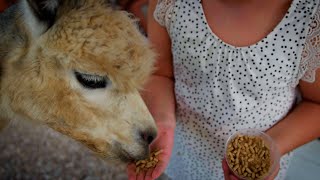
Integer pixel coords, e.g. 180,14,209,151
225,129,280,180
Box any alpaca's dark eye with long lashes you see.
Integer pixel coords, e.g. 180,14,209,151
74,72,108,89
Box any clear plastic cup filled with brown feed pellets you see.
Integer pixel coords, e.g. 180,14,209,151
225,129,280,180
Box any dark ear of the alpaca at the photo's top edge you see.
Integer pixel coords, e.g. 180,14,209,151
26,0,61,29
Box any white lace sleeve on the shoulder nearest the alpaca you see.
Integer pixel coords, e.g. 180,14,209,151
153,0,175,30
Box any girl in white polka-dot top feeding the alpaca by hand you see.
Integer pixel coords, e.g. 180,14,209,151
128,0,320,180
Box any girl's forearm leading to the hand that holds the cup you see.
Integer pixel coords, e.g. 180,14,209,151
267,101,320,155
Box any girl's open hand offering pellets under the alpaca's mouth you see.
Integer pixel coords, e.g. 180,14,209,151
127,125,174,180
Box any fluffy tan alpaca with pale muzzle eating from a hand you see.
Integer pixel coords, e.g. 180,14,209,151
0,0,157,163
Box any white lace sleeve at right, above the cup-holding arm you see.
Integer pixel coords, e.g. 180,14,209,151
298,6,320,83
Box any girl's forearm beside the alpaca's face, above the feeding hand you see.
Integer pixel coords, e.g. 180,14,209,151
142,75,176,129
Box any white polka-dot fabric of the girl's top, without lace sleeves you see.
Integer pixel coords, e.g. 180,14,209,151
154,0,318,180
